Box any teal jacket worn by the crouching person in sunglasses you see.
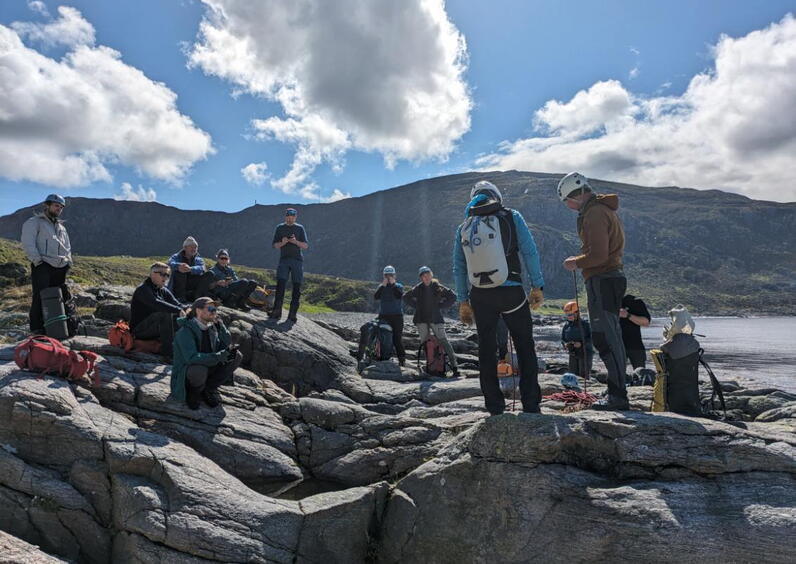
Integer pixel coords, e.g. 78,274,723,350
170,317,232,401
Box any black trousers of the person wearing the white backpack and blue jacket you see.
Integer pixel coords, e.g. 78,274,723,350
470,286,542,415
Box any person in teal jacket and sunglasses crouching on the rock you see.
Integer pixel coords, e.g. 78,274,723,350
171,297,243,409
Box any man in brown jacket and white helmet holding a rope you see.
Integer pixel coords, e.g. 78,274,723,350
558,172,629,410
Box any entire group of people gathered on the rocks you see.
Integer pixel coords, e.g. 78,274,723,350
22,172,649,414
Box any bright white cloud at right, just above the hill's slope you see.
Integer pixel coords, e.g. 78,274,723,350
478,15,796,201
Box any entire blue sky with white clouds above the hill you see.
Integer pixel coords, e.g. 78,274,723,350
0,0,796,214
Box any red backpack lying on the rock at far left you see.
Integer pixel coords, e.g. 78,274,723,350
14,335,99,386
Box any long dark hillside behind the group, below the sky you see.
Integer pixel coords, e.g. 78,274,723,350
0,171,796,313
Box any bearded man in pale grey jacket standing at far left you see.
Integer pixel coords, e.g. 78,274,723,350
21,194,72,335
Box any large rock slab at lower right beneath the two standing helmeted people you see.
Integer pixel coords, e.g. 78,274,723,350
379,412,796,562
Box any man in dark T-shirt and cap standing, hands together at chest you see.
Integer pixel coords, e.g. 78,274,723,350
270,208,309,321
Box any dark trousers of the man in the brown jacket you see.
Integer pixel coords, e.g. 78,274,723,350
586,270,627,403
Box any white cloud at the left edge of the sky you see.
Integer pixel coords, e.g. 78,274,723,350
0,6,213,187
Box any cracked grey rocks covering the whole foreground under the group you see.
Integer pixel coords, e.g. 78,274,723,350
0,288,796,563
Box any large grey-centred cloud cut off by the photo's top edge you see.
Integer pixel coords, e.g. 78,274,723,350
189,0,472,198
